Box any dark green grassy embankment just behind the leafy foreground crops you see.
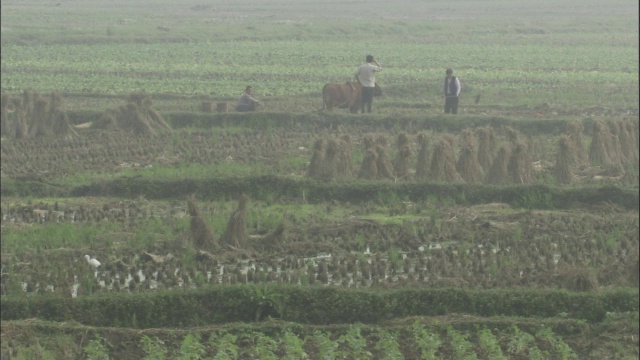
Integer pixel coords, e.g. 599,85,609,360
2,285,638,328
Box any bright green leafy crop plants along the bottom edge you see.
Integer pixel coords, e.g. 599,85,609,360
3,318,616,360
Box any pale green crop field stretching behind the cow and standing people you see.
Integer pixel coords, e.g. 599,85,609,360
2,41,638,102
